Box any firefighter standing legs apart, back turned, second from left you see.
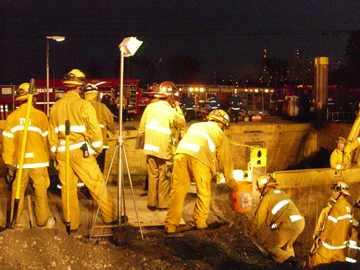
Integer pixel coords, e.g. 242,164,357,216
49,69,117,231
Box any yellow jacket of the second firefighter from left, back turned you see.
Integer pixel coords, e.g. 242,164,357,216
49,91,103,155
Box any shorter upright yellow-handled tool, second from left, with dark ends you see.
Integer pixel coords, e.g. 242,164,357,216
65,120,70,235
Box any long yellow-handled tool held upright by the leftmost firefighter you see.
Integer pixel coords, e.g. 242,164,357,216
11,78,35,229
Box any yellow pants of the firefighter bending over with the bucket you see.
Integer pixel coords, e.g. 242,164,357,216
165,154,212,232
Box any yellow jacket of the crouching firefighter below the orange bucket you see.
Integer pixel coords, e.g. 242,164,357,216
251,189,303,231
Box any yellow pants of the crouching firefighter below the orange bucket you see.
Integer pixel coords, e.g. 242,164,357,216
263,219,305,263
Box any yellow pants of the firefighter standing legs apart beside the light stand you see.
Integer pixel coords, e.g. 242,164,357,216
56,149,117,230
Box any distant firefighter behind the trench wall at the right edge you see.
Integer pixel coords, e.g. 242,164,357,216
330,137,360,170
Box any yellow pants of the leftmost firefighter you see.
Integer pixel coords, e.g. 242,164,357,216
11,167,50,226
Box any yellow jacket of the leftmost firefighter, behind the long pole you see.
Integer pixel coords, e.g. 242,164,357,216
2,103,49,169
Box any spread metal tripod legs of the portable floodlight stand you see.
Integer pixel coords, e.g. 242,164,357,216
89,136,144,241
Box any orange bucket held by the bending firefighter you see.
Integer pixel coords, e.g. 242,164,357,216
231,181,253,212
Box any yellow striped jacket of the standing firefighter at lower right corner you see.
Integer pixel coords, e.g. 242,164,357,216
320,198,353,250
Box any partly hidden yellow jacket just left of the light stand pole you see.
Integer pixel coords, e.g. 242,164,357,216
89,99,115,149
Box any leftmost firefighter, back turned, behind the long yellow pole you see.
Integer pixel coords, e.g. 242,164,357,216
2,83,51,227
